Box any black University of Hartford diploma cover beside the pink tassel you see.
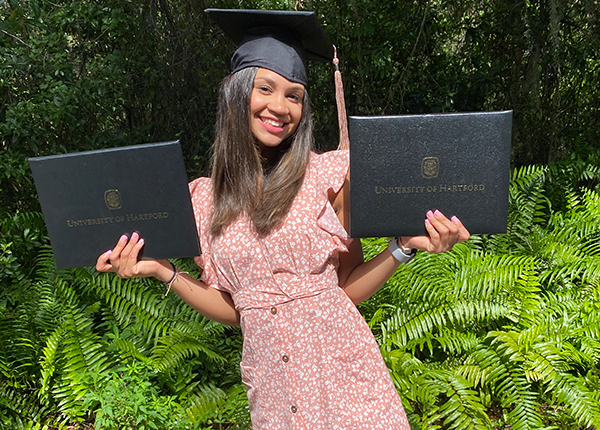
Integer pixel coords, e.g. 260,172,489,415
348,111,512,237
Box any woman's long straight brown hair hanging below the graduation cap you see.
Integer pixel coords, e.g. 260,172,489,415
210,67,313,237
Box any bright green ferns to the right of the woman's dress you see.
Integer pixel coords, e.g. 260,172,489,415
367,160,600,430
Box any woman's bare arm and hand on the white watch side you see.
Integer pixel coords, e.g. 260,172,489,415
329,178,470,304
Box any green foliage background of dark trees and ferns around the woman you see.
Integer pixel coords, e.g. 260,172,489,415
0,0,600,430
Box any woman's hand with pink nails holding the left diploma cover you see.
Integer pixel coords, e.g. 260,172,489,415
96,232,173,280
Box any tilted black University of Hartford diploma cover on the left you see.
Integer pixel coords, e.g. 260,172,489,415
29,142,200,268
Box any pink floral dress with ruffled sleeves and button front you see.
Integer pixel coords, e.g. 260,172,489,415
190,151,410,430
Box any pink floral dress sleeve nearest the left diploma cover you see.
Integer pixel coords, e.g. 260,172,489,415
189,177,226,291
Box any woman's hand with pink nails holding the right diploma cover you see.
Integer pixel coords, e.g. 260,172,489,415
399,210,471,254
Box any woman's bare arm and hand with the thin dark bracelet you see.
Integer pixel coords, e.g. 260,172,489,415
96,233,240,326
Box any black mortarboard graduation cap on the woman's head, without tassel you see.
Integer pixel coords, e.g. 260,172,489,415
205,9,334,86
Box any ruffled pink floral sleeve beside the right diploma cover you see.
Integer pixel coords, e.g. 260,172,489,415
311,150,351,251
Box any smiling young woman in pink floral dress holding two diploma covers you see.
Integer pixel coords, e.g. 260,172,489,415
97,11,469,430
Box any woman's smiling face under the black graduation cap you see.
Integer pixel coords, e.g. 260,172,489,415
250,68,304,155
